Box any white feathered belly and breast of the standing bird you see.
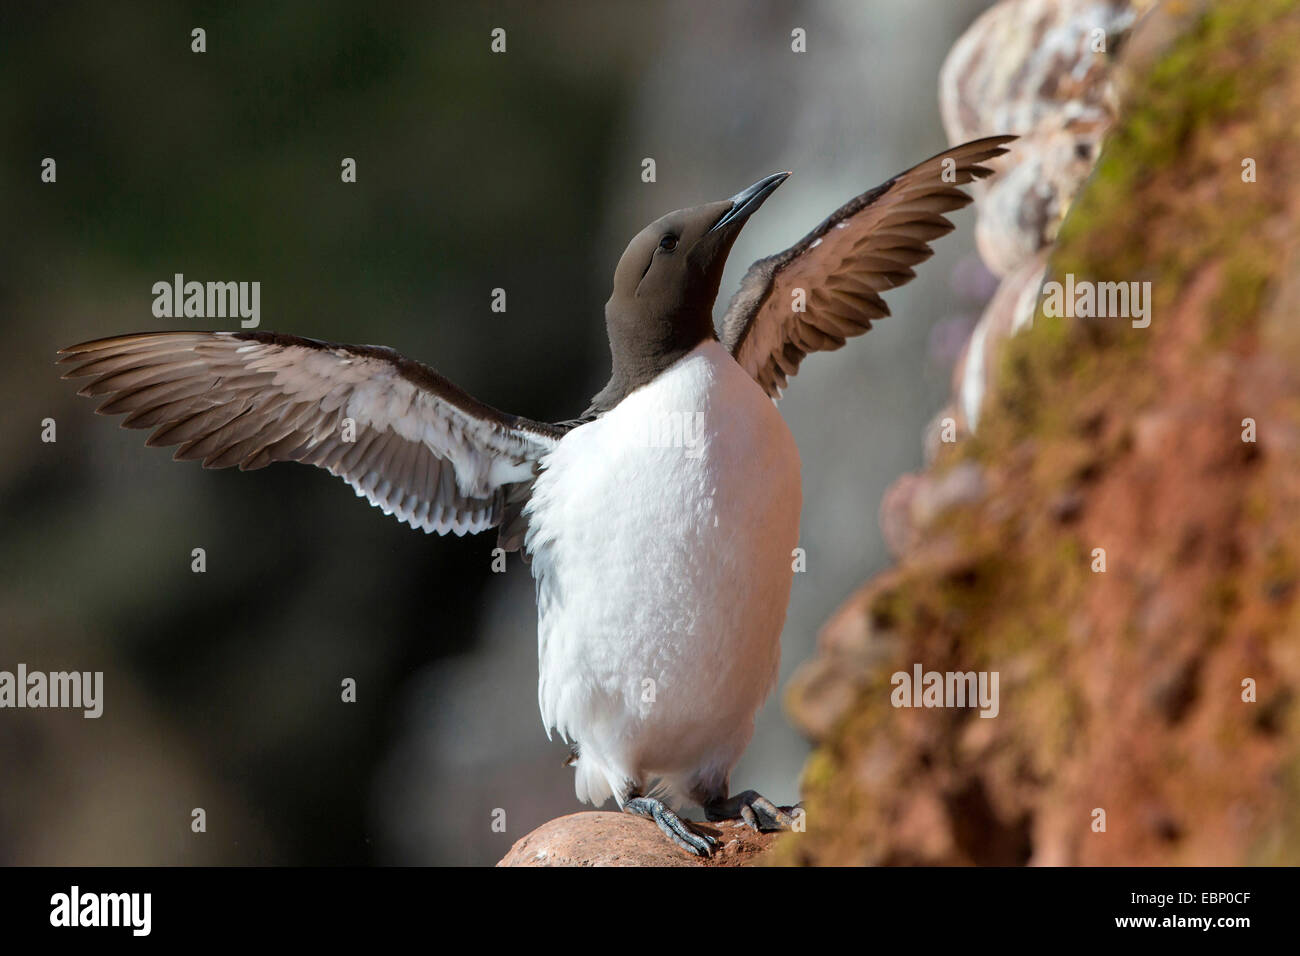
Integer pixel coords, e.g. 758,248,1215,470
527,342,801,804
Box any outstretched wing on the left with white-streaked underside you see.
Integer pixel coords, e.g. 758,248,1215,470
59,332,564,535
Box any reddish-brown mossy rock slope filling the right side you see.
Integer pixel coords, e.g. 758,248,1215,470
774,0,1300,865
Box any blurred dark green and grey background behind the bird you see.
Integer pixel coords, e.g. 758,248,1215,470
0,0,993,864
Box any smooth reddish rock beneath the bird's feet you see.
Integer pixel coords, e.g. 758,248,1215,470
497,810,777,866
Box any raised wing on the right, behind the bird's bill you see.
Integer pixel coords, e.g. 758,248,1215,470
722,137,1015,398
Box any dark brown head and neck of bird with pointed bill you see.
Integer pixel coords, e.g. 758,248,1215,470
588,173,789,414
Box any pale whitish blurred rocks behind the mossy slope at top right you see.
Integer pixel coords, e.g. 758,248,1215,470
927,0,1154,439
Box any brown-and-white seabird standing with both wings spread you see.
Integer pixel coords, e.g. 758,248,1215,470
57,135,1014,857
